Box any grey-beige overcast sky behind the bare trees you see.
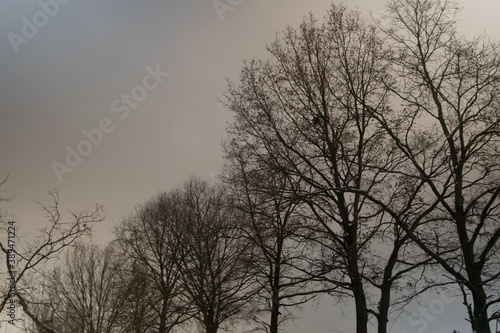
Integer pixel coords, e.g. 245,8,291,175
0,0,500,333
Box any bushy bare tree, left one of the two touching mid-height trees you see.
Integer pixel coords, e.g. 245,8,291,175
115,191,192,333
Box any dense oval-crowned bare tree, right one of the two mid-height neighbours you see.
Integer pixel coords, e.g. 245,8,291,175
174,178,254,333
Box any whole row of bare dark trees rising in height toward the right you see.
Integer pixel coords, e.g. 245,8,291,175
2,0,500,333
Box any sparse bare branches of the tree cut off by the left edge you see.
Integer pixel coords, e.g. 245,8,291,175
0,191,103,332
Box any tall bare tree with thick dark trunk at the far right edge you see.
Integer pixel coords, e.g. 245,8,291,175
358,0,500,333
